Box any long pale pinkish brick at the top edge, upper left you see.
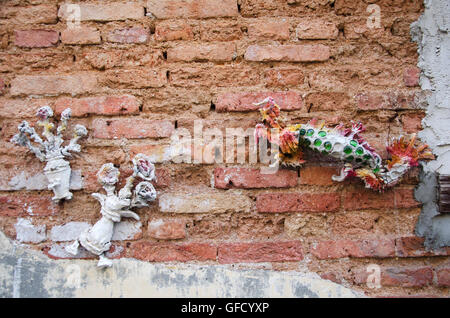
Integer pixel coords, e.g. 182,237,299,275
58,2,144,21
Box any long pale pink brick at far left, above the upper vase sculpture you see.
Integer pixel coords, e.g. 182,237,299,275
10,73,97,96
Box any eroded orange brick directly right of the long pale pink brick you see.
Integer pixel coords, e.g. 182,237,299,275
103,69,167,88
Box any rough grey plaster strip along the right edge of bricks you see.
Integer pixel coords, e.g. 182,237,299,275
411,1,450,247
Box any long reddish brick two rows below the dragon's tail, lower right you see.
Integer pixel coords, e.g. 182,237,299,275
311,239,395,259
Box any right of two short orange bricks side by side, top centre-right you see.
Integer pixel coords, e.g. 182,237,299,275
295,18,339,40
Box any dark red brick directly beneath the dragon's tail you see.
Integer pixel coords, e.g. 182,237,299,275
343,188,420,210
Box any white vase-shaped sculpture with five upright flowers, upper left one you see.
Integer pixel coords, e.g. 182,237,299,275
11,106,87,202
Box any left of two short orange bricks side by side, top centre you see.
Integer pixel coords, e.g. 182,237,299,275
247,19,289,40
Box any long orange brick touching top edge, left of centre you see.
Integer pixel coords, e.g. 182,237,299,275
146,0,239,19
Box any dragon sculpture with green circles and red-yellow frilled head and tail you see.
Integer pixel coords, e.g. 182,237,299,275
254,97,434,191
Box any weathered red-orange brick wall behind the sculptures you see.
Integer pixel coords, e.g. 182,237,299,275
0,0,444,296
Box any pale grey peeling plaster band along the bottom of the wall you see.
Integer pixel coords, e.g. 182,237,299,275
0,232,363,298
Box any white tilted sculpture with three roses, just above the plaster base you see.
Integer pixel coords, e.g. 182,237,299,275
66,154,156,267
